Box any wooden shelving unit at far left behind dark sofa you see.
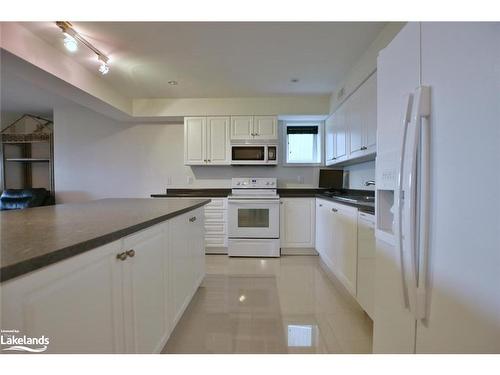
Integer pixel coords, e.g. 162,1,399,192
0,114,54,196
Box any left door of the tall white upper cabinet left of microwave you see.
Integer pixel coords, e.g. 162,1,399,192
184,117,207,165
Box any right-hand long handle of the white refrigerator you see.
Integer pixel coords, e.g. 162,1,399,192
414,86,430,319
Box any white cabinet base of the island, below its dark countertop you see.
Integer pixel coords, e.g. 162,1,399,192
1,207,205,353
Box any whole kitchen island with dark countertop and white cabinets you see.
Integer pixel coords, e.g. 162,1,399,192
0,199,210,353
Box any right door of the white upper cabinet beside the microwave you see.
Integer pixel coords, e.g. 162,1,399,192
207,117,231,165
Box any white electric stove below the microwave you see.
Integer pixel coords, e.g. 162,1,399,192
228,177,280,257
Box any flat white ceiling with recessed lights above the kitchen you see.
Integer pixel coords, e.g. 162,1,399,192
23,22,385,98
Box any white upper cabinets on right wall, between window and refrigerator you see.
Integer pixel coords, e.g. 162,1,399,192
325,74,377,165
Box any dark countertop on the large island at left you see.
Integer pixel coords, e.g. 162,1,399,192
0,198,210,282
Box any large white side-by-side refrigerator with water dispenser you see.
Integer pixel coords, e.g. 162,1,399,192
373,22,500,353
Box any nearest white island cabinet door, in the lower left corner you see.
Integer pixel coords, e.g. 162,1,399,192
1,241,125,354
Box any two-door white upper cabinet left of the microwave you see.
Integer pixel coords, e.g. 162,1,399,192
184,117,231,165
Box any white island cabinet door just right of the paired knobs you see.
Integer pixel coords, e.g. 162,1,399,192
123,224,168,353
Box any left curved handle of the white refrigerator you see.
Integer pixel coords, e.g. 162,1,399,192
396,94,413,309
